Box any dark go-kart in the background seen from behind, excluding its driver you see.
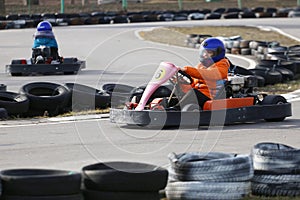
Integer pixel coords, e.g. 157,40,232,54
6,46,85,76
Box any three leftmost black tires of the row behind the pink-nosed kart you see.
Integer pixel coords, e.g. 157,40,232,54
0,82,111,119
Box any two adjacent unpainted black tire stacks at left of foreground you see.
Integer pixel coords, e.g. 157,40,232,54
0,162,168,200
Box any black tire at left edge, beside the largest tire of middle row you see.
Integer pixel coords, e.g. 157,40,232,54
0,91,29,115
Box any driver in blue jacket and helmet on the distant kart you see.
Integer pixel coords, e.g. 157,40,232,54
32,21,60,60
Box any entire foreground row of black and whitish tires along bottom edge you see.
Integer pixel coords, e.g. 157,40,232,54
0,142,300,200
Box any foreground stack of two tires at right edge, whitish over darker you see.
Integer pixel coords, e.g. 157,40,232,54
251,143,300,197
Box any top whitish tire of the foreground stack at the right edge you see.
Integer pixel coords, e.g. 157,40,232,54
251,142,300,174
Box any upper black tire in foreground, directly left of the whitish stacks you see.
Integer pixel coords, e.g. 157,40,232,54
82,162,168,192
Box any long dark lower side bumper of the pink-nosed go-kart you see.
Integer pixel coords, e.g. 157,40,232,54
110,103,292,127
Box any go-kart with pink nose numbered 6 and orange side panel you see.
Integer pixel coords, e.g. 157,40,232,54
110,62,292,127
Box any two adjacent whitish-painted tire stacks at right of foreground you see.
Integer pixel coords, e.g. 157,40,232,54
165,143,300,200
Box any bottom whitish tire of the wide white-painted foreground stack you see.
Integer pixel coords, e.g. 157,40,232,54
166,181,251,200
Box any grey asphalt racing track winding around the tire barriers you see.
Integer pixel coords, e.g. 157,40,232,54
0,18,300,170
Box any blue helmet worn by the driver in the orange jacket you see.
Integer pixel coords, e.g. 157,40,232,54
200,37,225,63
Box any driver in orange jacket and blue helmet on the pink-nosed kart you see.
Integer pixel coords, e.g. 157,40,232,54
179,37,230,108
